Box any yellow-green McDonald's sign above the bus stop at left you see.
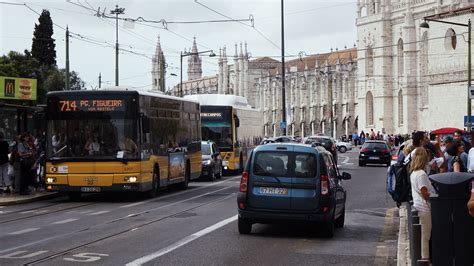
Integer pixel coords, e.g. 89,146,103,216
0,77,37,101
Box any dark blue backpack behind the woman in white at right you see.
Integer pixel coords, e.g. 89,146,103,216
387,156,412,207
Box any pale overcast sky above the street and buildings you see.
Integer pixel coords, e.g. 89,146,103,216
0,0,357,89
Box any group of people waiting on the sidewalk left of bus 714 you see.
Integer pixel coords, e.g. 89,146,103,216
0,131,44,195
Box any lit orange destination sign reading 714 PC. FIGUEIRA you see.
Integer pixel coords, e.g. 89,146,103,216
58,99,125,112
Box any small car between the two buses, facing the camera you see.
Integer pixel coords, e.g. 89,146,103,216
201,141,222,181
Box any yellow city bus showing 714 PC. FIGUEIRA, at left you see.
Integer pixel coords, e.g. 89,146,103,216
45,89,201,200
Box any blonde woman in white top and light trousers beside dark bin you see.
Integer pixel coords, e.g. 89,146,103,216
410,149,436,260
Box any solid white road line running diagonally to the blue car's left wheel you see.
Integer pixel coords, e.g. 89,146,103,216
126,215,237,266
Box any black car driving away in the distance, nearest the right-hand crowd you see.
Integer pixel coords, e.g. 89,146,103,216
359,140,391,166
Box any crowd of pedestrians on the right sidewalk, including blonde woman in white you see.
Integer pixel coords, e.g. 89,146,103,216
388,130,474,260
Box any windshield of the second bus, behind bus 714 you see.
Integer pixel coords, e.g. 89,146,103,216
201,119,233,151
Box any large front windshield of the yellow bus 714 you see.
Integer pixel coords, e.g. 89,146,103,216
47,118,139,160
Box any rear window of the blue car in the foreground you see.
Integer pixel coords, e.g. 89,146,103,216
253,151,317,178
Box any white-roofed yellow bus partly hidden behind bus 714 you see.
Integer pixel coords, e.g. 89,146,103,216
185,94,263,174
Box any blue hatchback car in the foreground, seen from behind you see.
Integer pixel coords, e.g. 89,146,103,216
237,143,351,237
